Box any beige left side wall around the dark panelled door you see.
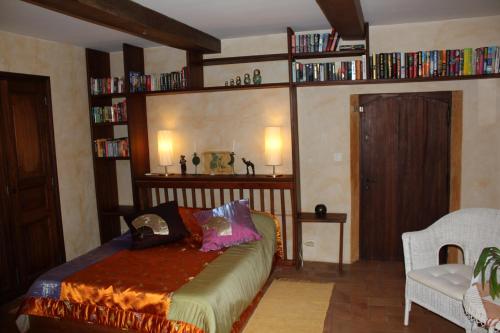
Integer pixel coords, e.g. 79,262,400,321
0,31,99,260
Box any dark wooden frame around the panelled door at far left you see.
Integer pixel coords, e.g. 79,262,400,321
0,71,66,264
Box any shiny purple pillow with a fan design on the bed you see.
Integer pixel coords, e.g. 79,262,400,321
194,200,262,252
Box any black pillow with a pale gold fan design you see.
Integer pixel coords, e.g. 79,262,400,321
124,201,188,249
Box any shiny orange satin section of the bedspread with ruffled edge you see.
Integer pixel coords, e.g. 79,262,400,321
23,242,222,332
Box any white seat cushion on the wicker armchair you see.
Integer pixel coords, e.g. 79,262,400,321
408,264,474,301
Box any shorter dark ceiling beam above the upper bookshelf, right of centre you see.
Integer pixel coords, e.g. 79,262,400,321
316,0,365,39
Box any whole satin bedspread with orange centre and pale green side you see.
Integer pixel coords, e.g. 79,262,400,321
20,213,282,333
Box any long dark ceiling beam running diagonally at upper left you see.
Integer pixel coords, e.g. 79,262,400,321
23,0,221,53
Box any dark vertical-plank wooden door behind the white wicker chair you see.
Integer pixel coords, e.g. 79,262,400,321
360,92,451,260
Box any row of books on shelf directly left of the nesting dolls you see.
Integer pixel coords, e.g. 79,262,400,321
129,67,188,92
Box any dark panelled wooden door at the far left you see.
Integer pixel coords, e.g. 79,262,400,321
1,76,65,291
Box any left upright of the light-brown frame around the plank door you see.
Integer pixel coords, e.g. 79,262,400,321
349,95,360,262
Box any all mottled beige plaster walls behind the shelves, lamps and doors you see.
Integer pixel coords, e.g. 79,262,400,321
0,17,500,261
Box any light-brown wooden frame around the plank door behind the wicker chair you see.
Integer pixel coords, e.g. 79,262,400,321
349,90,463,262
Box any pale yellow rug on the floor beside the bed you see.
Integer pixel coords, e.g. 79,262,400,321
243,280,334,333
